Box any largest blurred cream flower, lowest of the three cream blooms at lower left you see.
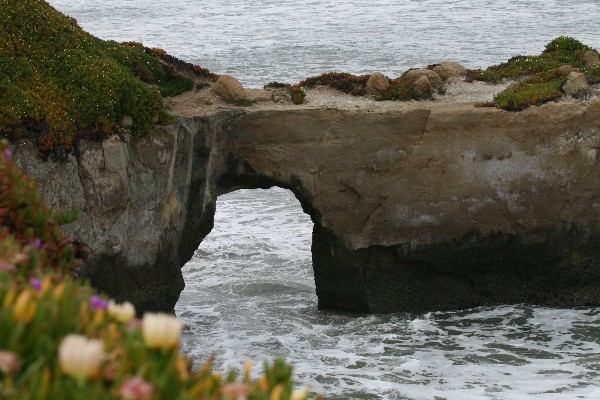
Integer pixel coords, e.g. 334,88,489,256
58,335,104,379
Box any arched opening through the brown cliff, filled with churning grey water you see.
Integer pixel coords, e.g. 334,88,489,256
176,187,317,320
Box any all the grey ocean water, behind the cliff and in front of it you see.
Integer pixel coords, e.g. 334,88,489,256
50,0,600,400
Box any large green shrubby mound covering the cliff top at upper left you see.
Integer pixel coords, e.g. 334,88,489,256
0,0,199,155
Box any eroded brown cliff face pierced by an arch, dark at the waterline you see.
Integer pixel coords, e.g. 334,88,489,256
14,101,600,312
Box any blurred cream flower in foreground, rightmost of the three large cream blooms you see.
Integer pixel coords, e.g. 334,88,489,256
142,313,181,349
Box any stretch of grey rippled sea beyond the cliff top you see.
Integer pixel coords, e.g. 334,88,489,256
44,0,600,86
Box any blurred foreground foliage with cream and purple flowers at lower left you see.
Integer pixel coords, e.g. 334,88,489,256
0,140,322,400
